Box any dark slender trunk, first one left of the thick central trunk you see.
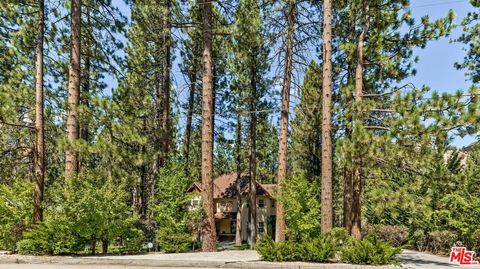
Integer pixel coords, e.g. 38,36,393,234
160,0,171,167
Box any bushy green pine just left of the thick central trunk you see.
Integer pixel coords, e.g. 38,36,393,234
112,1,175,237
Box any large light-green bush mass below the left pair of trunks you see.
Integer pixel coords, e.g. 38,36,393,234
18,172,143,255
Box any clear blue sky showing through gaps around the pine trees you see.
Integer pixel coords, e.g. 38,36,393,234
109,0,475,148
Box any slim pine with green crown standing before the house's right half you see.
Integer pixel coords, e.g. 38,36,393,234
233,0,268,248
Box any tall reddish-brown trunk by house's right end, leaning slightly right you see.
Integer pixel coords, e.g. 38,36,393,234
275,0,296,242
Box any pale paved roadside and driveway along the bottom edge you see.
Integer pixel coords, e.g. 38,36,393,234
0,250,460,269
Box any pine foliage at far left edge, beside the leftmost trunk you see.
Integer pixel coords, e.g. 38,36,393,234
0,1,38,180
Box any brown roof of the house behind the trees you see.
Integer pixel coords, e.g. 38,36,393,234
187,173,276,199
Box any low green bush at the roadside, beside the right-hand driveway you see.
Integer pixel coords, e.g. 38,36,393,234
341,231,401,265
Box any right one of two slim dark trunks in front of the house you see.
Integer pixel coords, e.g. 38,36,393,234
248,59,257,249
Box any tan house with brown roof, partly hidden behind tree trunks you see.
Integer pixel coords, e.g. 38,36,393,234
188,173,276,241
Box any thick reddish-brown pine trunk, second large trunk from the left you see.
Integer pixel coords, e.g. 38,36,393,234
65,0,82,179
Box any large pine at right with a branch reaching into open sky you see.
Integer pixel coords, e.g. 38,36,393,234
336,1,452,237
